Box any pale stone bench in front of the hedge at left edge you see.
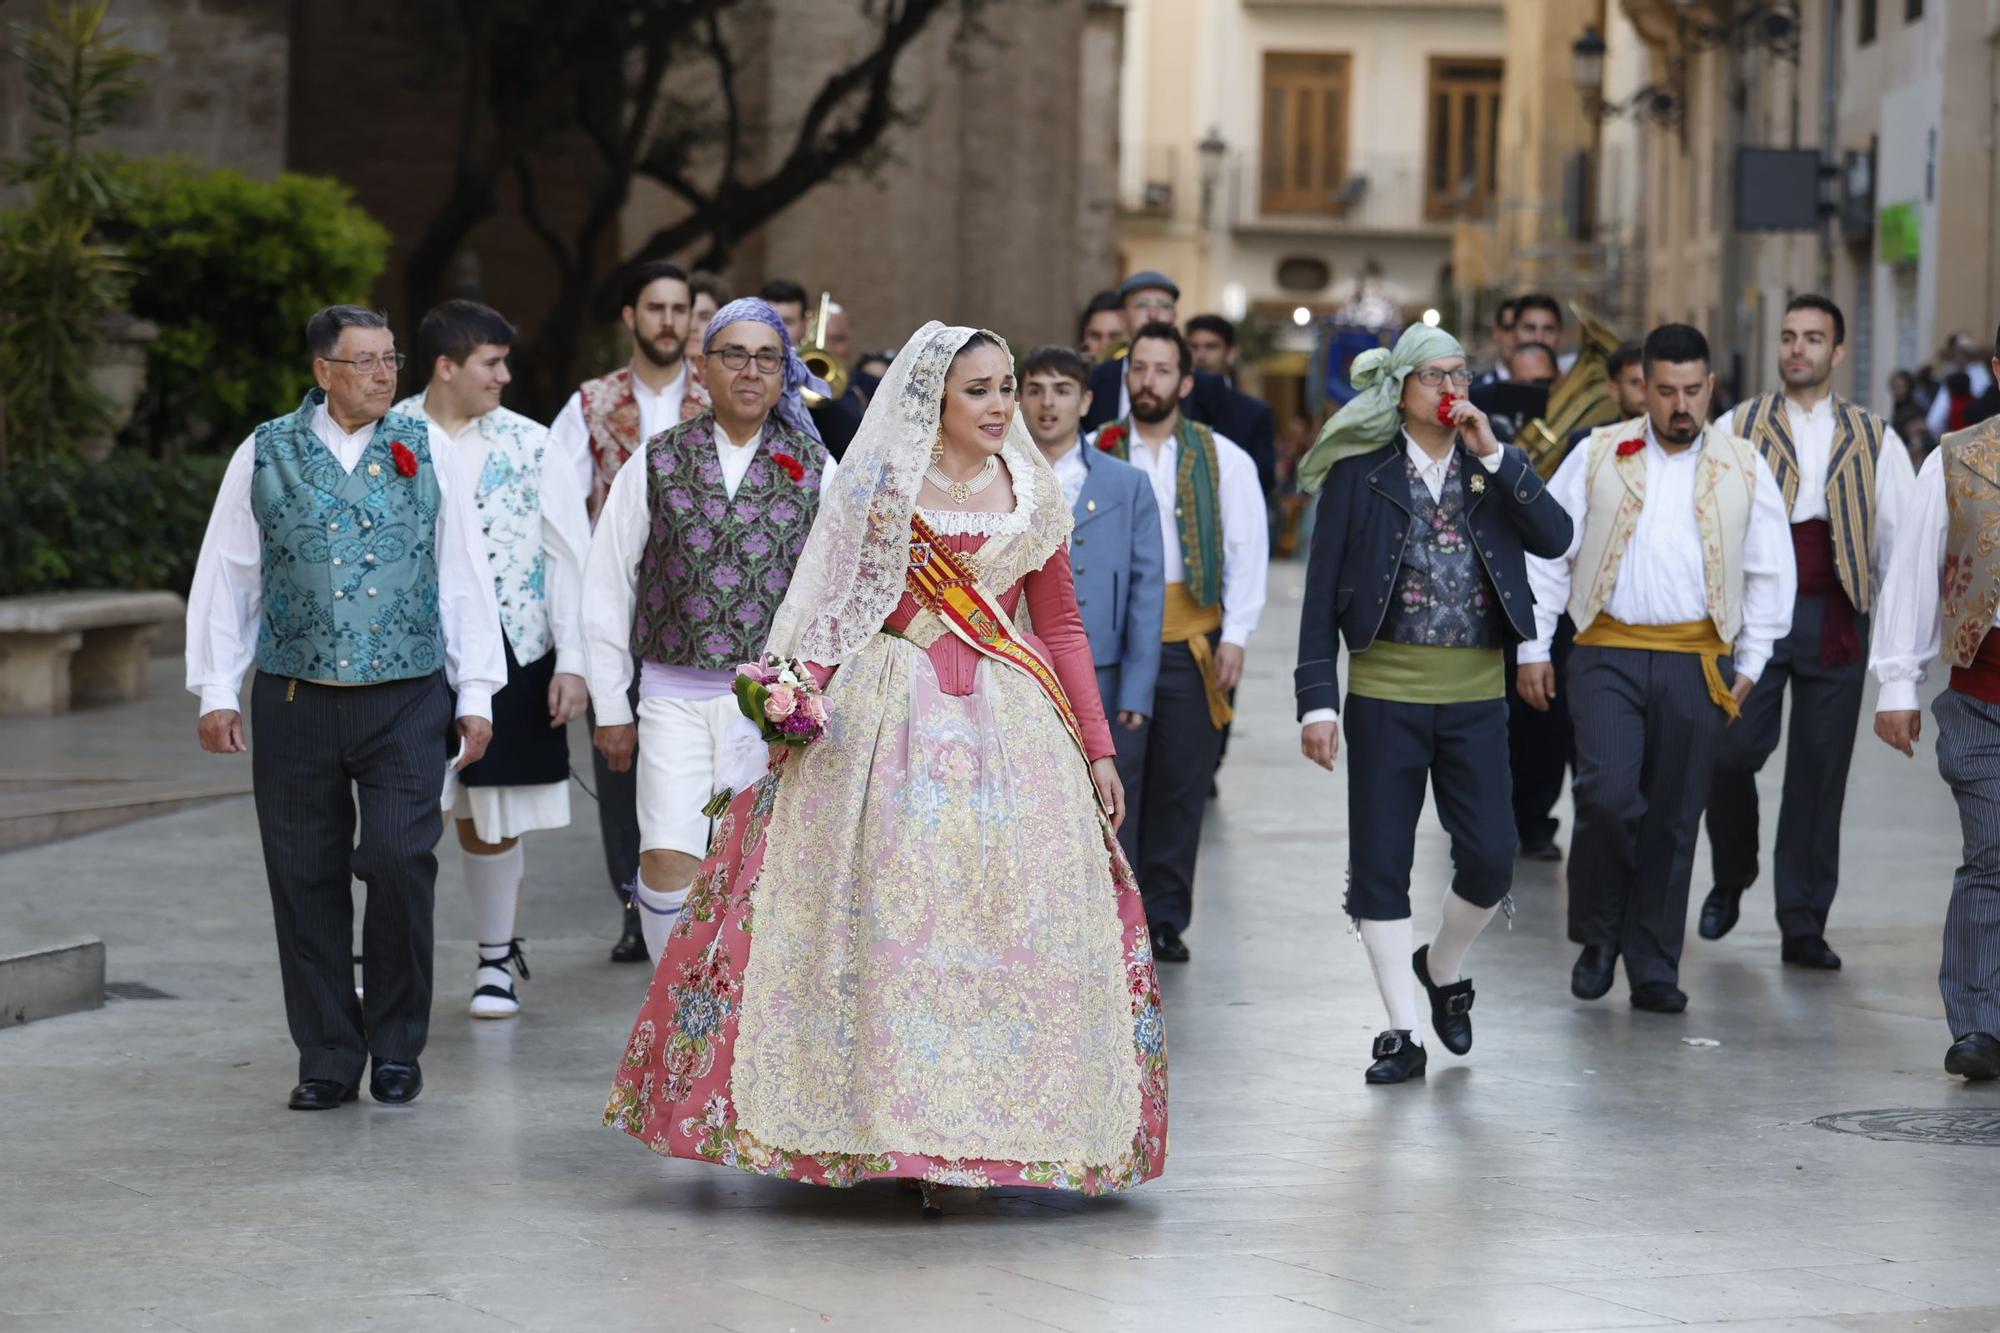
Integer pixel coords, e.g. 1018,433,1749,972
0,592,186,717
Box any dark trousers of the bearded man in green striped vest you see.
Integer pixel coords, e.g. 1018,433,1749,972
1128,634,1222,931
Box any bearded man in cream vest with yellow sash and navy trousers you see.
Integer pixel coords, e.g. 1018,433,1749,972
1516,324,1796,1013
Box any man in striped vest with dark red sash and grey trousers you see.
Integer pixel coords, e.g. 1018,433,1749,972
1698,294,1916,971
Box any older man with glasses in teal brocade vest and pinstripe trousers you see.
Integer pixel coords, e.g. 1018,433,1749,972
188,306,506,1111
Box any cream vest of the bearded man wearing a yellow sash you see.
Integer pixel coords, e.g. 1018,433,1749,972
1570,416,1756,642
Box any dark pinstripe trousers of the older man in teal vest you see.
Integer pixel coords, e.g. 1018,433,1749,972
250,673,454,1087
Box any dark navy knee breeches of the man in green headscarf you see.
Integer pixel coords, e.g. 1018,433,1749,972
1342,695,1514,921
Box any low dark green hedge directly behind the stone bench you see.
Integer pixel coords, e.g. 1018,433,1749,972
0,450,228,596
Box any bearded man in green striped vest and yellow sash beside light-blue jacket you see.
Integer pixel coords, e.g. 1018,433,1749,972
1092,320,1270,963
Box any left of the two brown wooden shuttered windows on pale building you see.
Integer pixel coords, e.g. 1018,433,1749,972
1258,52,1348,214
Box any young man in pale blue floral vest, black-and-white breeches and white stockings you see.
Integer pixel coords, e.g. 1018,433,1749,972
396,300,590,1019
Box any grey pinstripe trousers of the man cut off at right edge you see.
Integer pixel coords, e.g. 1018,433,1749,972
1930,691,2000,1041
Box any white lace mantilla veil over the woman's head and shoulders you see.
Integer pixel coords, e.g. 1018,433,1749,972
764,320,1072,667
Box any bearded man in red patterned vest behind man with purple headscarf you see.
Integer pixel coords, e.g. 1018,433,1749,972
550,260,708,963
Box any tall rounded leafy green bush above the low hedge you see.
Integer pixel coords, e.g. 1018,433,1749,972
100,158,390,454
